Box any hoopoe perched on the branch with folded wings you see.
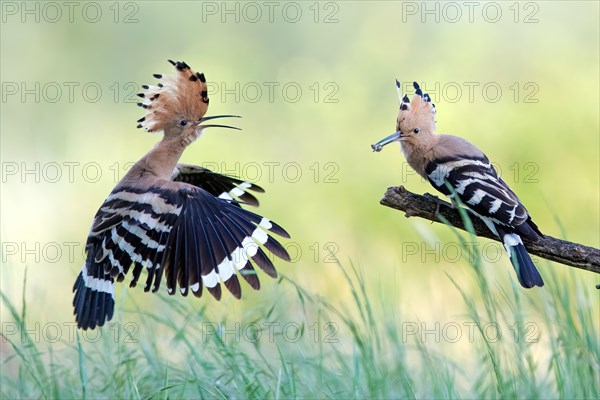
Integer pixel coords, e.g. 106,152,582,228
371,81,544,288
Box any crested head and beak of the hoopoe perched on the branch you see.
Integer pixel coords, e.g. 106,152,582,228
371,80,435,151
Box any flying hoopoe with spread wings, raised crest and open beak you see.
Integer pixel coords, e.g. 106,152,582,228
73,60,290,329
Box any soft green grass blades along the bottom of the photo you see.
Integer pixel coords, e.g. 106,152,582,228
0,230,600,399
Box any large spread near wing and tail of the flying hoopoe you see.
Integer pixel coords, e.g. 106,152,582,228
74,181,290,328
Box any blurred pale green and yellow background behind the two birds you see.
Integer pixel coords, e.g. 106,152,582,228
0,1,600,388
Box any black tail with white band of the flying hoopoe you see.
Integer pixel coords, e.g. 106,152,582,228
73,262,115,330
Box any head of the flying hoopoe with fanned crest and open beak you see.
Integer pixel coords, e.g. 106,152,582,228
137,60,239,140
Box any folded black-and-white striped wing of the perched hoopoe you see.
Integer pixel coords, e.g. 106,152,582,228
425,156,529,227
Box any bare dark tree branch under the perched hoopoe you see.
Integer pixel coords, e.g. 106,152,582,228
380,186,600,274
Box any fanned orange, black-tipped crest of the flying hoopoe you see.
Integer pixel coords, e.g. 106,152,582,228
137,60,208,132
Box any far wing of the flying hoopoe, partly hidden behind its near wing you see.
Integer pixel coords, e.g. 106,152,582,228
173,164,265,206
